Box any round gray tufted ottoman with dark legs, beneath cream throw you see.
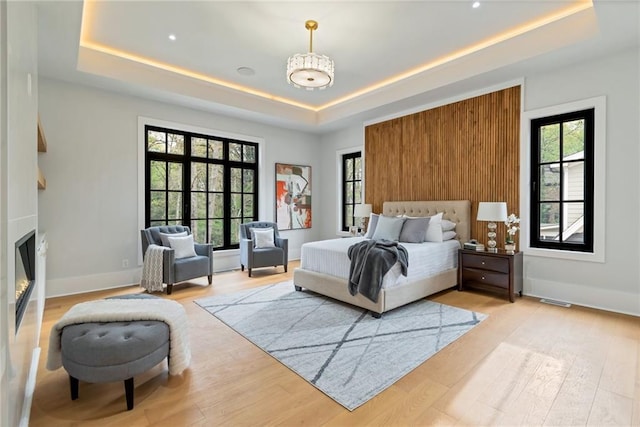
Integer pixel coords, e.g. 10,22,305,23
61,320,169,410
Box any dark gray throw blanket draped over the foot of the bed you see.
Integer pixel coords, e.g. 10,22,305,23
347,240,409,302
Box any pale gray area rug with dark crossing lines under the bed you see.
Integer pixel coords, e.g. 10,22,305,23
195,281,487,411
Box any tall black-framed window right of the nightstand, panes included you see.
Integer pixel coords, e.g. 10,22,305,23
530,108,595,252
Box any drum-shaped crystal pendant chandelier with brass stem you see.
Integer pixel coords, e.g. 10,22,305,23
287,20,334,90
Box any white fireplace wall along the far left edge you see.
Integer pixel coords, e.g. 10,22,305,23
0,2,39,426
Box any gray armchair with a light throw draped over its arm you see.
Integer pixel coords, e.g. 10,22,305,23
140,225,213,295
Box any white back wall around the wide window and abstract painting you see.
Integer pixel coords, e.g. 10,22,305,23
39,78,326,296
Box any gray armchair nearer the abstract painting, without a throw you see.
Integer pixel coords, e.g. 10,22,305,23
240,221,289,277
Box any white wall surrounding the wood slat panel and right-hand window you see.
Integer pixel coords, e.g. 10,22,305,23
322,49,640,315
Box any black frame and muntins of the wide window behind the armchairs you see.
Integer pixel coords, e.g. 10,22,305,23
144,125,260,251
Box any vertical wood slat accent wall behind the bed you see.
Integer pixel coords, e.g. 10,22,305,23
365,86,520,247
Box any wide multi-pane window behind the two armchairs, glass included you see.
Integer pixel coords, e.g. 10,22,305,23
145,125,258,249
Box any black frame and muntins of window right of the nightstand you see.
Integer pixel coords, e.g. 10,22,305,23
529,108,595,253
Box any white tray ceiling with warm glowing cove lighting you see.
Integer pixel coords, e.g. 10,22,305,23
37,0,640,132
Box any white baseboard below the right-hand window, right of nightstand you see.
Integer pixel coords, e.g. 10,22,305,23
524,278,640,316
